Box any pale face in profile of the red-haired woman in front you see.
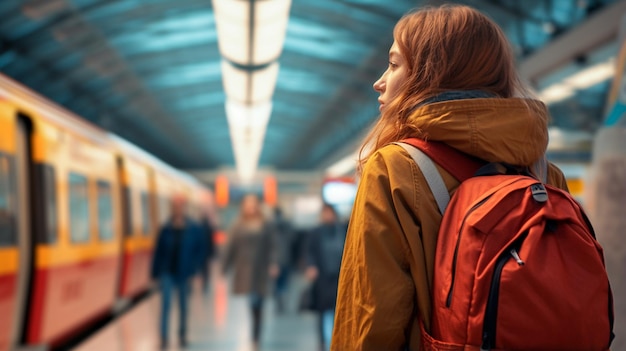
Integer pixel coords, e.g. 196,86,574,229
374,41,408,112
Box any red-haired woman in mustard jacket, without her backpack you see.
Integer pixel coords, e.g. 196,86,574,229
331,5,608,351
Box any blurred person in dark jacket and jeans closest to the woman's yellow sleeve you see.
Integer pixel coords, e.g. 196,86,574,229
305,204,347,351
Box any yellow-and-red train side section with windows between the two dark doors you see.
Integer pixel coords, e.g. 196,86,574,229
27,115,121,344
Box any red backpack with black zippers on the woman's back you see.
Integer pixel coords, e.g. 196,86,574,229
398,139,613,351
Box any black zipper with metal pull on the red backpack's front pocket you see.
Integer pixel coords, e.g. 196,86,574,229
480,233,528,351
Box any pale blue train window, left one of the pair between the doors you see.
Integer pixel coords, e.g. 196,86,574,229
69,173,89,243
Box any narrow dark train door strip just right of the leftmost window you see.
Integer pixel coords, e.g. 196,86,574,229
11,116,33,345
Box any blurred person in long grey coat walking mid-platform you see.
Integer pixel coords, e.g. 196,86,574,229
224,195,279,350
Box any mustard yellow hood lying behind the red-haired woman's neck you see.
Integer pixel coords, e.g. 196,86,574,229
407,98,548,166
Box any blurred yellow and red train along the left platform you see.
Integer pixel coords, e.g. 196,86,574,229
0,75,210,351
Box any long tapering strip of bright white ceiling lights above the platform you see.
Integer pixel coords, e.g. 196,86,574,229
213,0,291,182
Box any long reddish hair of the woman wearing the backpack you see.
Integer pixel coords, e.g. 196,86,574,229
359,5,531,169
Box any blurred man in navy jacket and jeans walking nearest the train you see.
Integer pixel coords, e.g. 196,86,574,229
151,195,203,349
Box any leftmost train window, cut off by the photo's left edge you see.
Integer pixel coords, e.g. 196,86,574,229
0,154,17,246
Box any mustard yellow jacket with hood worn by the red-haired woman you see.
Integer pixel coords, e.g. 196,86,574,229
331,98,567,351
